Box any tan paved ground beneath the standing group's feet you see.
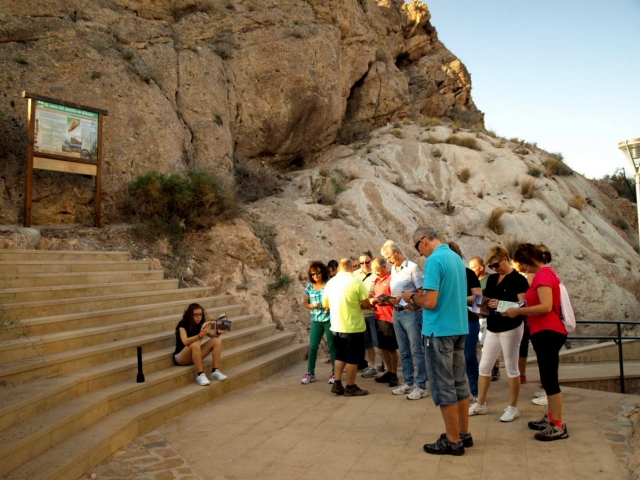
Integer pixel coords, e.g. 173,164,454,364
82,363,640,480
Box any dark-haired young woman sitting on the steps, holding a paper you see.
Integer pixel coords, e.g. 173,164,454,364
173,303,227,386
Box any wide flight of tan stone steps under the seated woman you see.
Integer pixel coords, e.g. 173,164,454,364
0,250,307,479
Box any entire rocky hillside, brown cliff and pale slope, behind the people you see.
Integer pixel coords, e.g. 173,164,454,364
0,0,640,338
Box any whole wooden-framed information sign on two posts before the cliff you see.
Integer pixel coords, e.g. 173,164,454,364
22,92,109,227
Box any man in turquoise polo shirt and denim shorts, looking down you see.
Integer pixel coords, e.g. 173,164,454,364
403,227,473,455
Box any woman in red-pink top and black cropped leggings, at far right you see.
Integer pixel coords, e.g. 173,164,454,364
503,243,569,441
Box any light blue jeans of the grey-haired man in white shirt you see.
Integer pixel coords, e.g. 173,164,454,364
393,310,427,388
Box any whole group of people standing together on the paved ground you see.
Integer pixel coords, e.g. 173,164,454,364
302,227,568,455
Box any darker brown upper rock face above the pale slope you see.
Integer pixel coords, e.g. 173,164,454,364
0,0,483,224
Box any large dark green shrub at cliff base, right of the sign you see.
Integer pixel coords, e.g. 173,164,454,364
123,170,230,247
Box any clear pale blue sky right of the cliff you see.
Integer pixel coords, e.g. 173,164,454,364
424,0,640,178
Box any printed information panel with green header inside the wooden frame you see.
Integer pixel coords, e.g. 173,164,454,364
34,100,98,162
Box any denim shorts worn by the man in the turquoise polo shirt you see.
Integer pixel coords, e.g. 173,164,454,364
422,335,471,406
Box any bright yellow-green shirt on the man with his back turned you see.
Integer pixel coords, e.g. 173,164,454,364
323,272,369,333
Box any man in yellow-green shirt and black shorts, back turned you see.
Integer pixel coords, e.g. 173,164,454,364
322,258,371,397
